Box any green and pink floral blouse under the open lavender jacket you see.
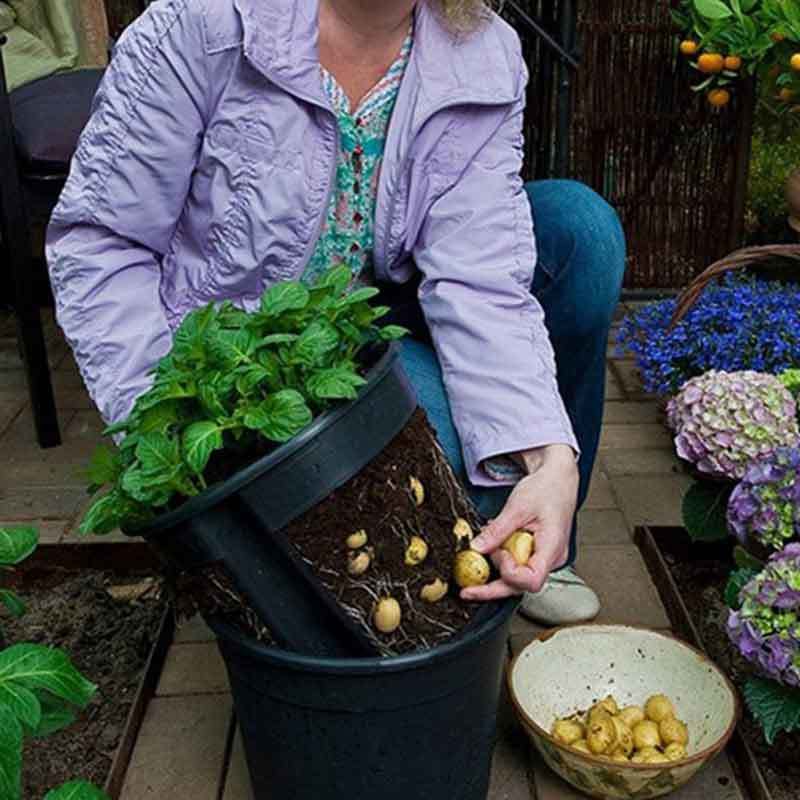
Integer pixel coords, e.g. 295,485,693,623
303,31,413,283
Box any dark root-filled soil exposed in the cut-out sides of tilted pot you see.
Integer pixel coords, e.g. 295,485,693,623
177,410,481,656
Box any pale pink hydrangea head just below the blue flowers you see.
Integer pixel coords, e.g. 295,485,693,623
667,370,800,481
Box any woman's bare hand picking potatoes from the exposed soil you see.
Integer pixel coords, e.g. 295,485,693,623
461,445,579,600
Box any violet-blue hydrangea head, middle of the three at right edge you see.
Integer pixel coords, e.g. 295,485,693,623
728,447,800,550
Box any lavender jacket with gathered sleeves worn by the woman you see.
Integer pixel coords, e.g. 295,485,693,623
47,0,577,485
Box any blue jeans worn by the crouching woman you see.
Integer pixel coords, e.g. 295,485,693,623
402,180,625,564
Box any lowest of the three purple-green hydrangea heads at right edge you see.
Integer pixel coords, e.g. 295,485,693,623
728,542,800,687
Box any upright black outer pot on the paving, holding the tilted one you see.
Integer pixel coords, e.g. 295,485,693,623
210,599,517,800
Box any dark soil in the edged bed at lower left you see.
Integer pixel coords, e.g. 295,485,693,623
3,570,165,800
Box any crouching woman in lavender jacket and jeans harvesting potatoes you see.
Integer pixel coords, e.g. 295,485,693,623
47,0,624,623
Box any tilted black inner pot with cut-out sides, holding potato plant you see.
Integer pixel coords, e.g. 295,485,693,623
126,345,417,657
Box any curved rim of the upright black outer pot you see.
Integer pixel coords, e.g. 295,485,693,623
207,597,520,676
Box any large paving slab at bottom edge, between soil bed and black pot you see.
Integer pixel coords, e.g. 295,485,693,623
120,695,231,800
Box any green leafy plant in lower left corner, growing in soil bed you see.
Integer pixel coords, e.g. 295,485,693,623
0,527,108,800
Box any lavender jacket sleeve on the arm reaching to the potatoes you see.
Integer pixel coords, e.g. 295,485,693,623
413,59,578,486
